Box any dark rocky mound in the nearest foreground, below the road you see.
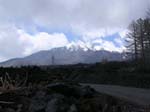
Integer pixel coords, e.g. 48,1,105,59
0,83,150,112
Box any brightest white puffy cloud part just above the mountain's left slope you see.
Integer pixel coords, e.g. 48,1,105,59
18,30,69,55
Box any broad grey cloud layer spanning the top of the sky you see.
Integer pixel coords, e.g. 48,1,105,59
0,0,149,29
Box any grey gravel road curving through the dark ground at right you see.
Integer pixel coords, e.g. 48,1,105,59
82,84,150,106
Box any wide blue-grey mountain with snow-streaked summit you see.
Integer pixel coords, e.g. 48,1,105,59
0,45,123,67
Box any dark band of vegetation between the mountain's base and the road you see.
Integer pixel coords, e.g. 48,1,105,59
0,62,150,88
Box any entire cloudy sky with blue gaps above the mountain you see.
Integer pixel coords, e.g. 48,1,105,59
0,0,150,62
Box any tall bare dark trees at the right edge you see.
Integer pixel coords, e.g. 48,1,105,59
126,10,150,65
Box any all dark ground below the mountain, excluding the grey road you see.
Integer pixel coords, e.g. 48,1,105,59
0,62,150,112
